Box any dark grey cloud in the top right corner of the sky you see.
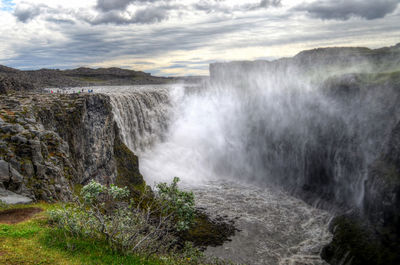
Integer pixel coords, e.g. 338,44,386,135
294,0,400,20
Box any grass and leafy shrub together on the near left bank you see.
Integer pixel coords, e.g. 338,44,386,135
0,178,234,265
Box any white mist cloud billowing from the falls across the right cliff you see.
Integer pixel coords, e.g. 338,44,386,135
140,51,399,206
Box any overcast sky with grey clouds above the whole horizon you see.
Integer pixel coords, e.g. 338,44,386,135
0,0,400,76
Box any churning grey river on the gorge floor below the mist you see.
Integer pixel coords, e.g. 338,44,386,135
188,181,331,265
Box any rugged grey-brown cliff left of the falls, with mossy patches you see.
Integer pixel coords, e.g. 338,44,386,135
0,93,144,201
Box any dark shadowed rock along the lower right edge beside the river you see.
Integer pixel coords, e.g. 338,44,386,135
322,120,400,265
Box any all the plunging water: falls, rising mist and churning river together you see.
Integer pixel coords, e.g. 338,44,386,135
97,56,400,264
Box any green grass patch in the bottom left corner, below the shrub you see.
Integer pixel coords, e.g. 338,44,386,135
0,203,200,265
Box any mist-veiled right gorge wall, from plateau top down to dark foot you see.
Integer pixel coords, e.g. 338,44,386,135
210,42,400,265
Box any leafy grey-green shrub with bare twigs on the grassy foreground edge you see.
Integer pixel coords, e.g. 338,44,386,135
49,178,195,255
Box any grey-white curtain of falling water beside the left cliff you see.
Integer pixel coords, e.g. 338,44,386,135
100,86,171,153
